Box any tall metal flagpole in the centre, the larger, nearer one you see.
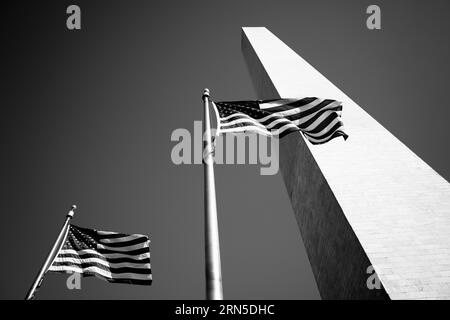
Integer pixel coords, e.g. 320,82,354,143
202,89,223,300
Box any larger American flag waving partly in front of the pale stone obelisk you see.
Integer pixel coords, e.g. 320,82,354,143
212,97,348,144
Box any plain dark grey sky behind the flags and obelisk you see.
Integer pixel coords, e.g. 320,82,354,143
0,0,450,299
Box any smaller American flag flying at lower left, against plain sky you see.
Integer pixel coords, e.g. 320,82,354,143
48,225,152,285
